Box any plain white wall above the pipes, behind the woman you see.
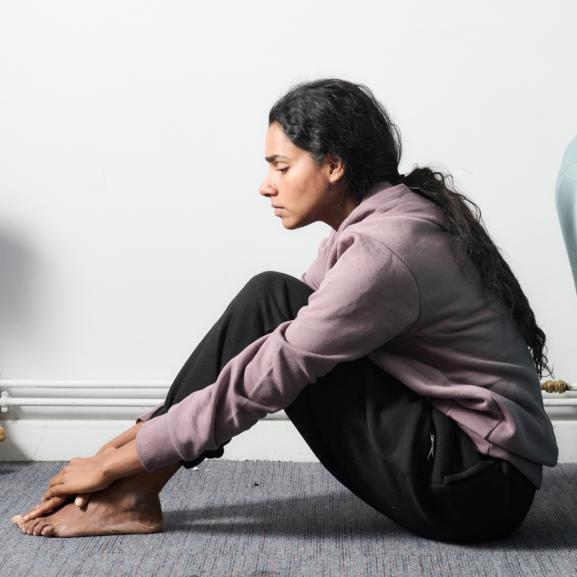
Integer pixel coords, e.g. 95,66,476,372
0,0,577,404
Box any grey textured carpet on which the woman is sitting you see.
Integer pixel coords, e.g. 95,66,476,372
0,459,577,577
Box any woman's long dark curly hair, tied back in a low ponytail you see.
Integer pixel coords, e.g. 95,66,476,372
268,78,553,377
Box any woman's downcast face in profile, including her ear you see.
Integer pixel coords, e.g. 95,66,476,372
259,122,354,230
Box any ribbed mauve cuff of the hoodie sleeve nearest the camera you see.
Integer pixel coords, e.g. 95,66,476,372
136,413,182,472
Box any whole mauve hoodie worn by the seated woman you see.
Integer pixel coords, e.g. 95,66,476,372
136,182,558,488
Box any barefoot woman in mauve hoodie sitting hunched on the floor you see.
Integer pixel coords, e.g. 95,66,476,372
14,79,558,542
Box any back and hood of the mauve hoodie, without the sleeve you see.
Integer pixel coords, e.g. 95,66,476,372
326,184,558,486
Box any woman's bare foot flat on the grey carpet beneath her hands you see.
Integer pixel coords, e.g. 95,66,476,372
14,477,162,537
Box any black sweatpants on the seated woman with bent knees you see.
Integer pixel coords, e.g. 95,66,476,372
147,271,536,542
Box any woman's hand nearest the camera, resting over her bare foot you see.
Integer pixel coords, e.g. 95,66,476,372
42,454,114,500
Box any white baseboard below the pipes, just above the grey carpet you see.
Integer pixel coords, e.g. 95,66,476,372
0,418,577,463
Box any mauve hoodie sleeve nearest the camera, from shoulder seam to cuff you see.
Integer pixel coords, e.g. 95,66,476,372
136,234,420,471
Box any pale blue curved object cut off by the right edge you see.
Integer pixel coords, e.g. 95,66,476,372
555,136,577,291
